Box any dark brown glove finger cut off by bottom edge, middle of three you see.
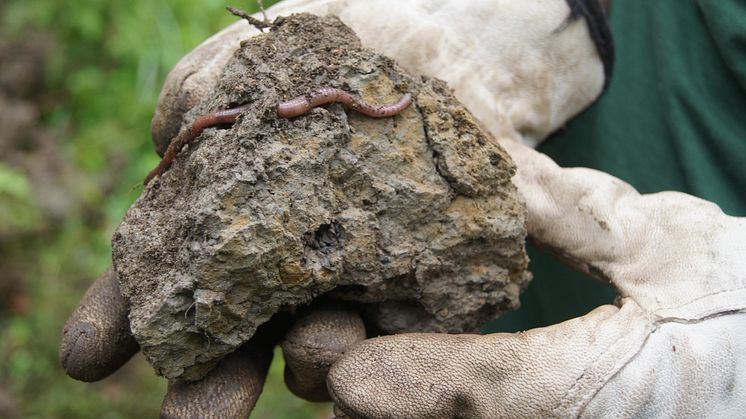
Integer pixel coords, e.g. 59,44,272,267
161,330,275,418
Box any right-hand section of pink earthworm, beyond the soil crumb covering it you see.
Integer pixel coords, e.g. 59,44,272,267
277,87,412,118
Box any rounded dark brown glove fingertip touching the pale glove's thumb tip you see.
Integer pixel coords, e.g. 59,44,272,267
281,305,365,401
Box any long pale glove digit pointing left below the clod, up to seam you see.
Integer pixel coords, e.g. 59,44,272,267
328,304,648,418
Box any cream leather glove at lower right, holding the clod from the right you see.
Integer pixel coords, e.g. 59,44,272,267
328,137,746,418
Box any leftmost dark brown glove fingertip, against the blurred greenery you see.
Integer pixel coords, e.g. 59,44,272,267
59,267,139,382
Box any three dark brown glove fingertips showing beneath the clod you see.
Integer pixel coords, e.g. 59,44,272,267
60,268,365,418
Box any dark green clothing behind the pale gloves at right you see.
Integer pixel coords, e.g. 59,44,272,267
486,0,746,331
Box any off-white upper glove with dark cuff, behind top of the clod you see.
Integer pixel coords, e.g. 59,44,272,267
152,0,613,155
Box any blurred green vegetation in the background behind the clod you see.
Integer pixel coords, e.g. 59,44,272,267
0,0,330,418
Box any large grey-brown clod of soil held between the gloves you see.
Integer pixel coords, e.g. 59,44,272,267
113,15,530,380
